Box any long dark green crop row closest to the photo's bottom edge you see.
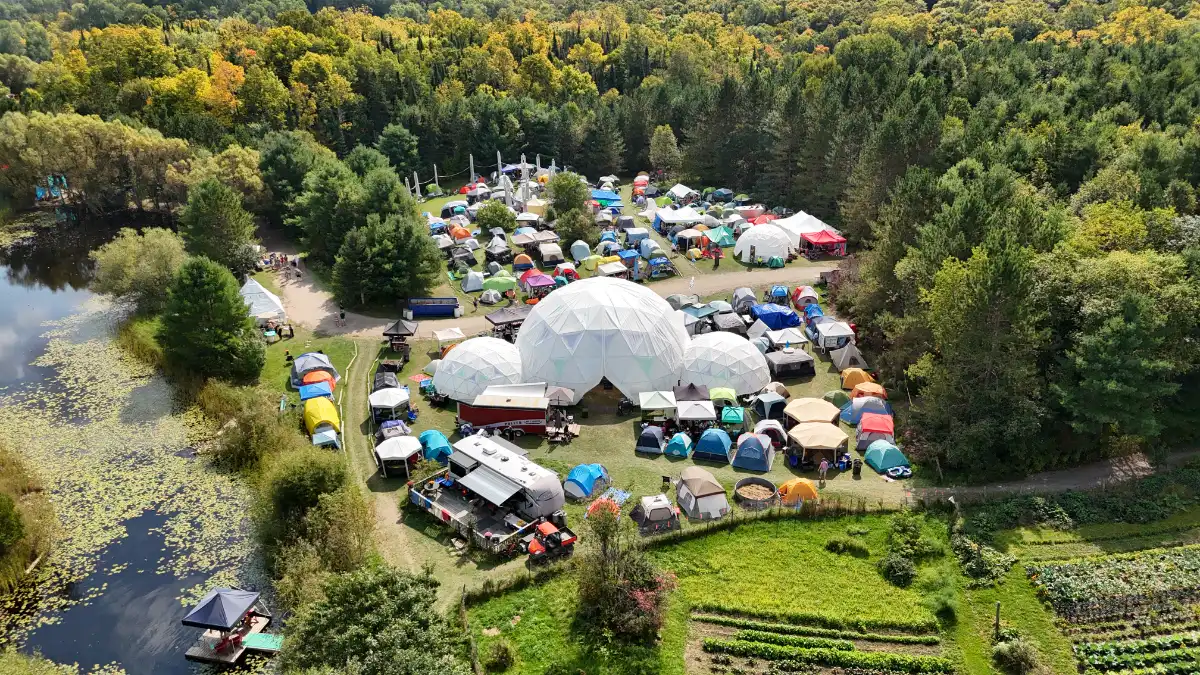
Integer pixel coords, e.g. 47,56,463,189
703,638,954,673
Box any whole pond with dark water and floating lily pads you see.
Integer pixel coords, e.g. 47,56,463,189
0,218,262,675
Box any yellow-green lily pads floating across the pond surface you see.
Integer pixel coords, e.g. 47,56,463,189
0,301,265,645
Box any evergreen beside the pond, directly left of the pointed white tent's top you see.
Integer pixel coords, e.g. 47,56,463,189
179,178,256,275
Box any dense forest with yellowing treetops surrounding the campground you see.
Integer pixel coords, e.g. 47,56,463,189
0,0,1200,473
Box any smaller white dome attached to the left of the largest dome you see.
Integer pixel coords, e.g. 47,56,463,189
433,338,522,404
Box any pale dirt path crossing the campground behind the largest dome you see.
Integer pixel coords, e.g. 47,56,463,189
272,254,835,338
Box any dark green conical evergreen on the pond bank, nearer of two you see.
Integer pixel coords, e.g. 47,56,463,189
157,257,265,382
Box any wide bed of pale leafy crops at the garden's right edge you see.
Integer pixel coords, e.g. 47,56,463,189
1030,538,1200,608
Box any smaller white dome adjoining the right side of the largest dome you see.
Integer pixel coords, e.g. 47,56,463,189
680,330,770,396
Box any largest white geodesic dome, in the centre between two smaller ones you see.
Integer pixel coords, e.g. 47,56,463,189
513,276,688,401
